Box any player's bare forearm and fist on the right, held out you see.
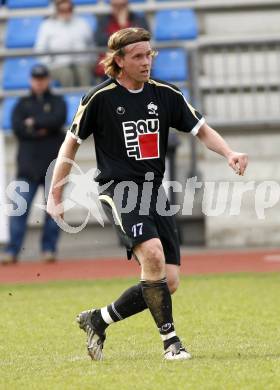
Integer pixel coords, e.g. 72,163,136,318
197,123,248,176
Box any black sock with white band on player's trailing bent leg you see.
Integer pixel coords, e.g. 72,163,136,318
92,283,147,333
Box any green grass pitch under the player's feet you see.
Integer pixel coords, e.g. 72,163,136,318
0,273,280,390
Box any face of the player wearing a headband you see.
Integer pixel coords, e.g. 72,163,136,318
119,42,154,88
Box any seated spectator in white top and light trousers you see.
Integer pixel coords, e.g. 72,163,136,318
35,0,93,87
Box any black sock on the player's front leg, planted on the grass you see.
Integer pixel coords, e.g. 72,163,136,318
141,278,179,349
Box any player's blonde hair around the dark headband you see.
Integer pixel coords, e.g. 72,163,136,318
100,27,151,78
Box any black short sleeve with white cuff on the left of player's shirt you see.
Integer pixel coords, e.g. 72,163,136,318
70,96,97,143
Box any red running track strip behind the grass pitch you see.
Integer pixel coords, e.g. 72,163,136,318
0,249,280,283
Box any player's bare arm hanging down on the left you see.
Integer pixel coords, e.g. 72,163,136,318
47,132,79,218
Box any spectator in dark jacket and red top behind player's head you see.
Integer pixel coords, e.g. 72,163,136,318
95,0,149,79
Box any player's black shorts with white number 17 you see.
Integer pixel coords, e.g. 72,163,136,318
99,183,180,265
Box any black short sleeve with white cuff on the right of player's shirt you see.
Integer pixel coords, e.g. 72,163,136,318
172,90,205,135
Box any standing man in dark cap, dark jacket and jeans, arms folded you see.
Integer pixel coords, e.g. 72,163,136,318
2,65,66,264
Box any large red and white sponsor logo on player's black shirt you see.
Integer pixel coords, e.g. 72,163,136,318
122,119,159,160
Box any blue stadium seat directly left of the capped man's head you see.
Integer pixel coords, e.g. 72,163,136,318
2,57,38,89
